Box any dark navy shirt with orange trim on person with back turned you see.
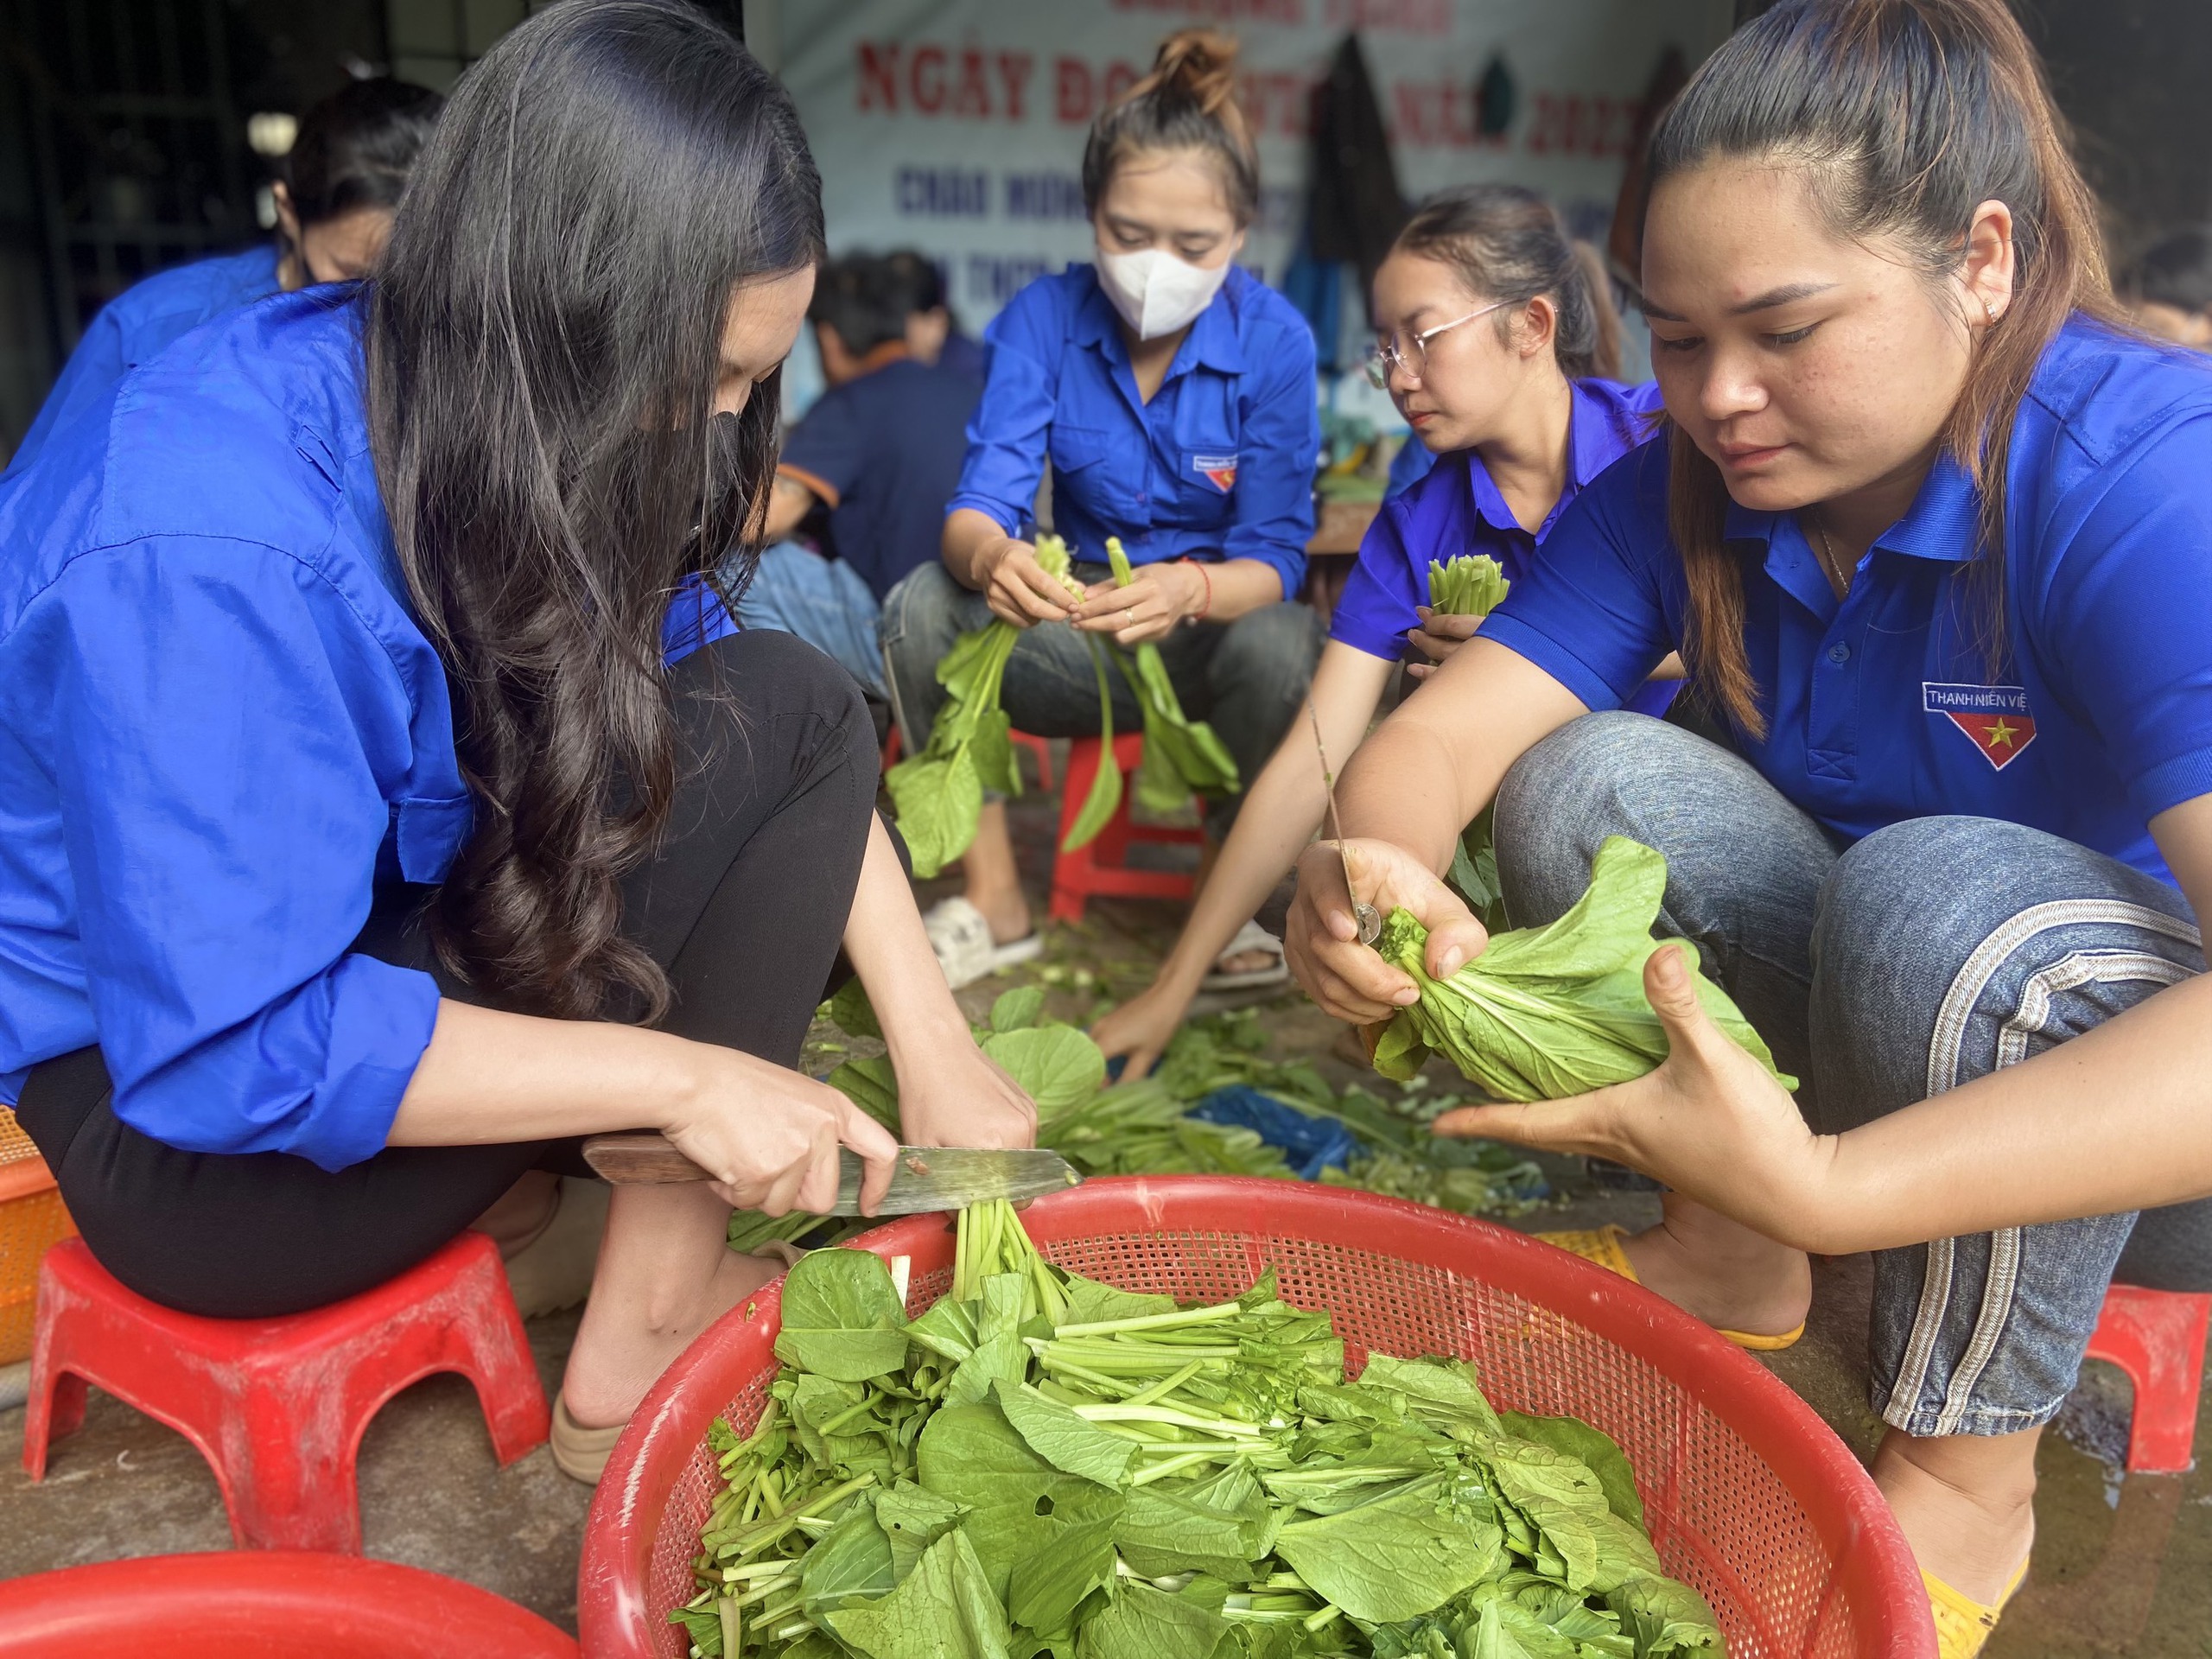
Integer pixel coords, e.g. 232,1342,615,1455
781,359,982,601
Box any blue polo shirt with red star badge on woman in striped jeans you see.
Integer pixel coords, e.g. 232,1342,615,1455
1482,319,2212,880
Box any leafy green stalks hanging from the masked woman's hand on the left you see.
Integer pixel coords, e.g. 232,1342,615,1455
882,536,1082,880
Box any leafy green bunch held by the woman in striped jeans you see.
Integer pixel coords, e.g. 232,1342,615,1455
1374,836,1796,1099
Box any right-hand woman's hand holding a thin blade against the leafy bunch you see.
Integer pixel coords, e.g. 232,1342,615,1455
1283,838,1491,1024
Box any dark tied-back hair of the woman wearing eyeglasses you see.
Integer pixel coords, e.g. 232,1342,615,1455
1391,183,1621,380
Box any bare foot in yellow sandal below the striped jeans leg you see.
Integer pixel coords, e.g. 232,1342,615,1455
1873,1429,2042,1606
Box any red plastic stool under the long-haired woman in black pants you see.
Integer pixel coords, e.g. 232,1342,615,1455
22,1232,550,1553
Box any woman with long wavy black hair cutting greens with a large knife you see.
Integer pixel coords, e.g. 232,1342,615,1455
0,0,1035,1473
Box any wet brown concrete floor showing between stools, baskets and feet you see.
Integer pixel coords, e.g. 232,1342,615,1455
0,797,2212,1659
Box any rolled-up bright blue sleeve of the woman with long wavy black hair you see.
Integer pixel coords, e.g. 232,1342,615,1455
46,537,438,1170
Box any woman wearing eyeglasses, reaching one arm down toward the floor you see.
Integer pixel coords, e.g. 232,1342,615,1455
1093,183,1681,1077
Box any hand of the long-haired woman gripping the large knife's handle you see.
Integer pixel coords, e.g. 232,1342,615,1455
664,1044,898,1214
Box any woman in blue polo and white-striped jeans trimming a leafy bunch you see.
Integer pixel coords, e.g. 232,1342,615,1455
1287,0,2212,1655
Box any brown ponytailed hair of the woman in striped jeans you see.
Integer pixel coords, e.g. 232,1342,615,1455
1650,0,2119,736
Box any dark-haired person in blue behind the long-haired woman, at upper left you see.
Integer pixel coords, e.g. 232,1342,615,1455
9,78,445,474
